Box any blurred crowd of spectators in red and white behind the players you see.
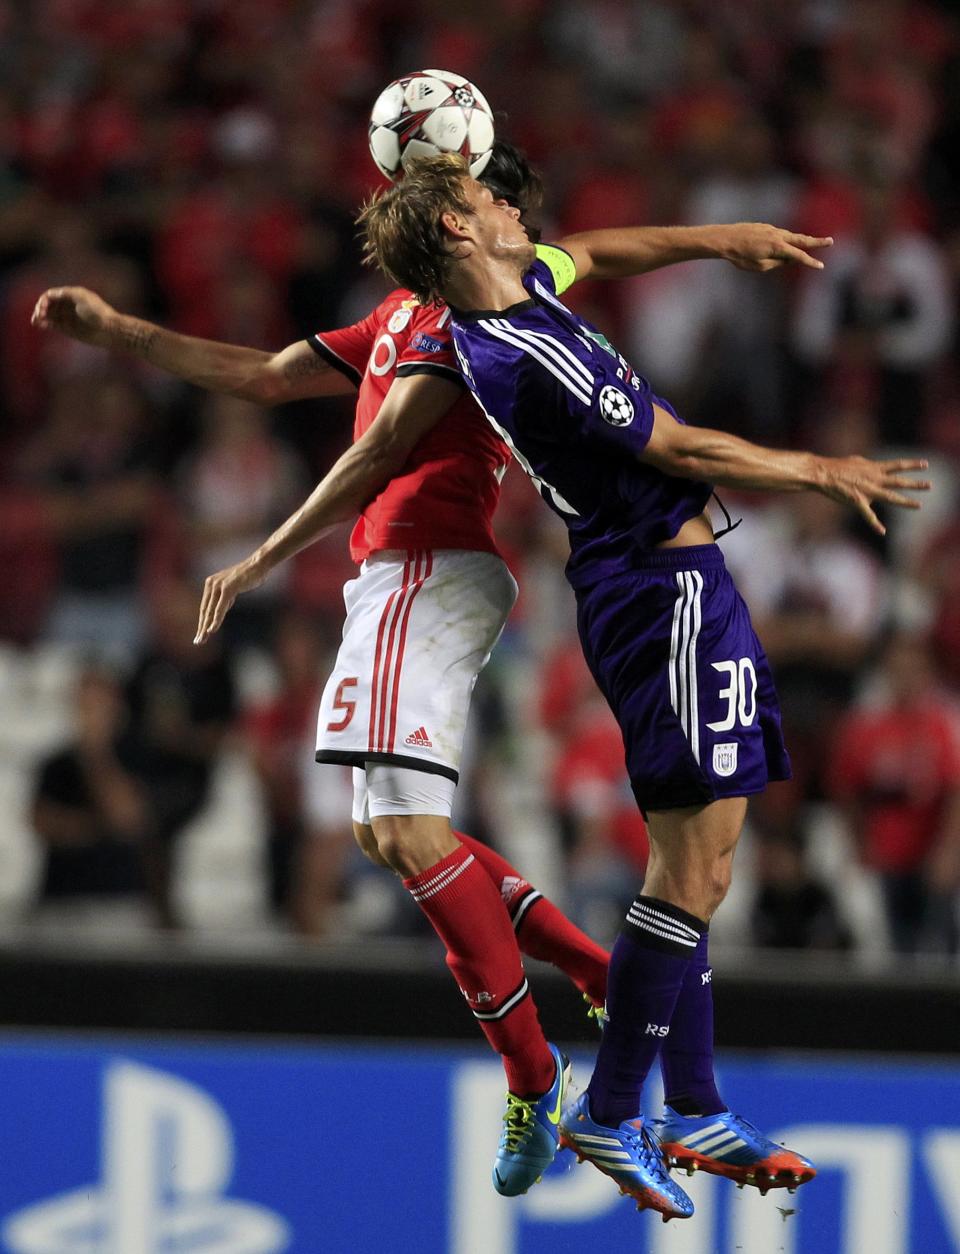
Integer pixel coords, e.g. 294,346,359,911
0,0,960,962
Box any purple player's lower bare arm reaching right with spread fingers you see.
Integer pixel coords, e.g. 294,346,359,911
640,405,930,535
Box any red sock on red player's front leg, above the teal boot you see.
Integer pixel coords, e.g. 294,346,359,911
404,845,556,1095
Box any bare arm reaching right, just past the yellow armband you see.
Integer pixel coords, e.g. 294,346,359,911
558,222,833,278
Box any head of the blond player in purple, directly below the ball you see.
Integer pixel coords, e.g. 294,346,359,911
357,154,534,303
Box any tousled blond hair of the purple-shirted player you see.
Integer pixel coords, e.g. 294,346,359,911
357,153,474,305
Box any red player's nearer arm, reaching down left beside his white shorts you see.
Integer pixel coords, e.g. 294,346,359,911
193,374,462,645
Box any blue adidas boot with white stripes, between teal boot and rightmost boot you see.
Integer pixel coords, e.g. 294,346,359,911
560,1093,693,1223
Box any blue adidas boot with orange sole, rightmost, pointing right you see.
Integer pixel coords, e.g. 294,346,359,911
655,1106,817,1193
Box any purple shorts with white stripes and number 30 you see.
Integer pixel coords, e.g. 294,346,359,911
577,544,790,810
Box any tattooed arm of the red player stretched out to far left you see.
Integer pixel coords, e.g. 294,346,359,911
30,287,353,405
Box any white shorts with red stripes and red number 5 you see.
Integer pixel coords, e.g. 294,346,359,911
316,549,516,782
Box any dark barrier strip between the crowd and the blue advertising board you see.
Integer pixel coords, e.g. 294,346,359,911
0,941,960,1056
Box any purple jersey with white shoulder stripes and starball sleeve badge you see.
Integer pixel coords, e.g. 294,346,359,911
452,261,712,588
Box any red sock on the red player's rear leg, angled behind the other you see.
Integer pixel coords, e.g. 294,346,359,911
454,831,610,1006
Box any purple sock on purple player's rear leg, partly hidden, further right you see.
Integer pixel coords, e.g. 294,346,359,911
660,927,727,1115
